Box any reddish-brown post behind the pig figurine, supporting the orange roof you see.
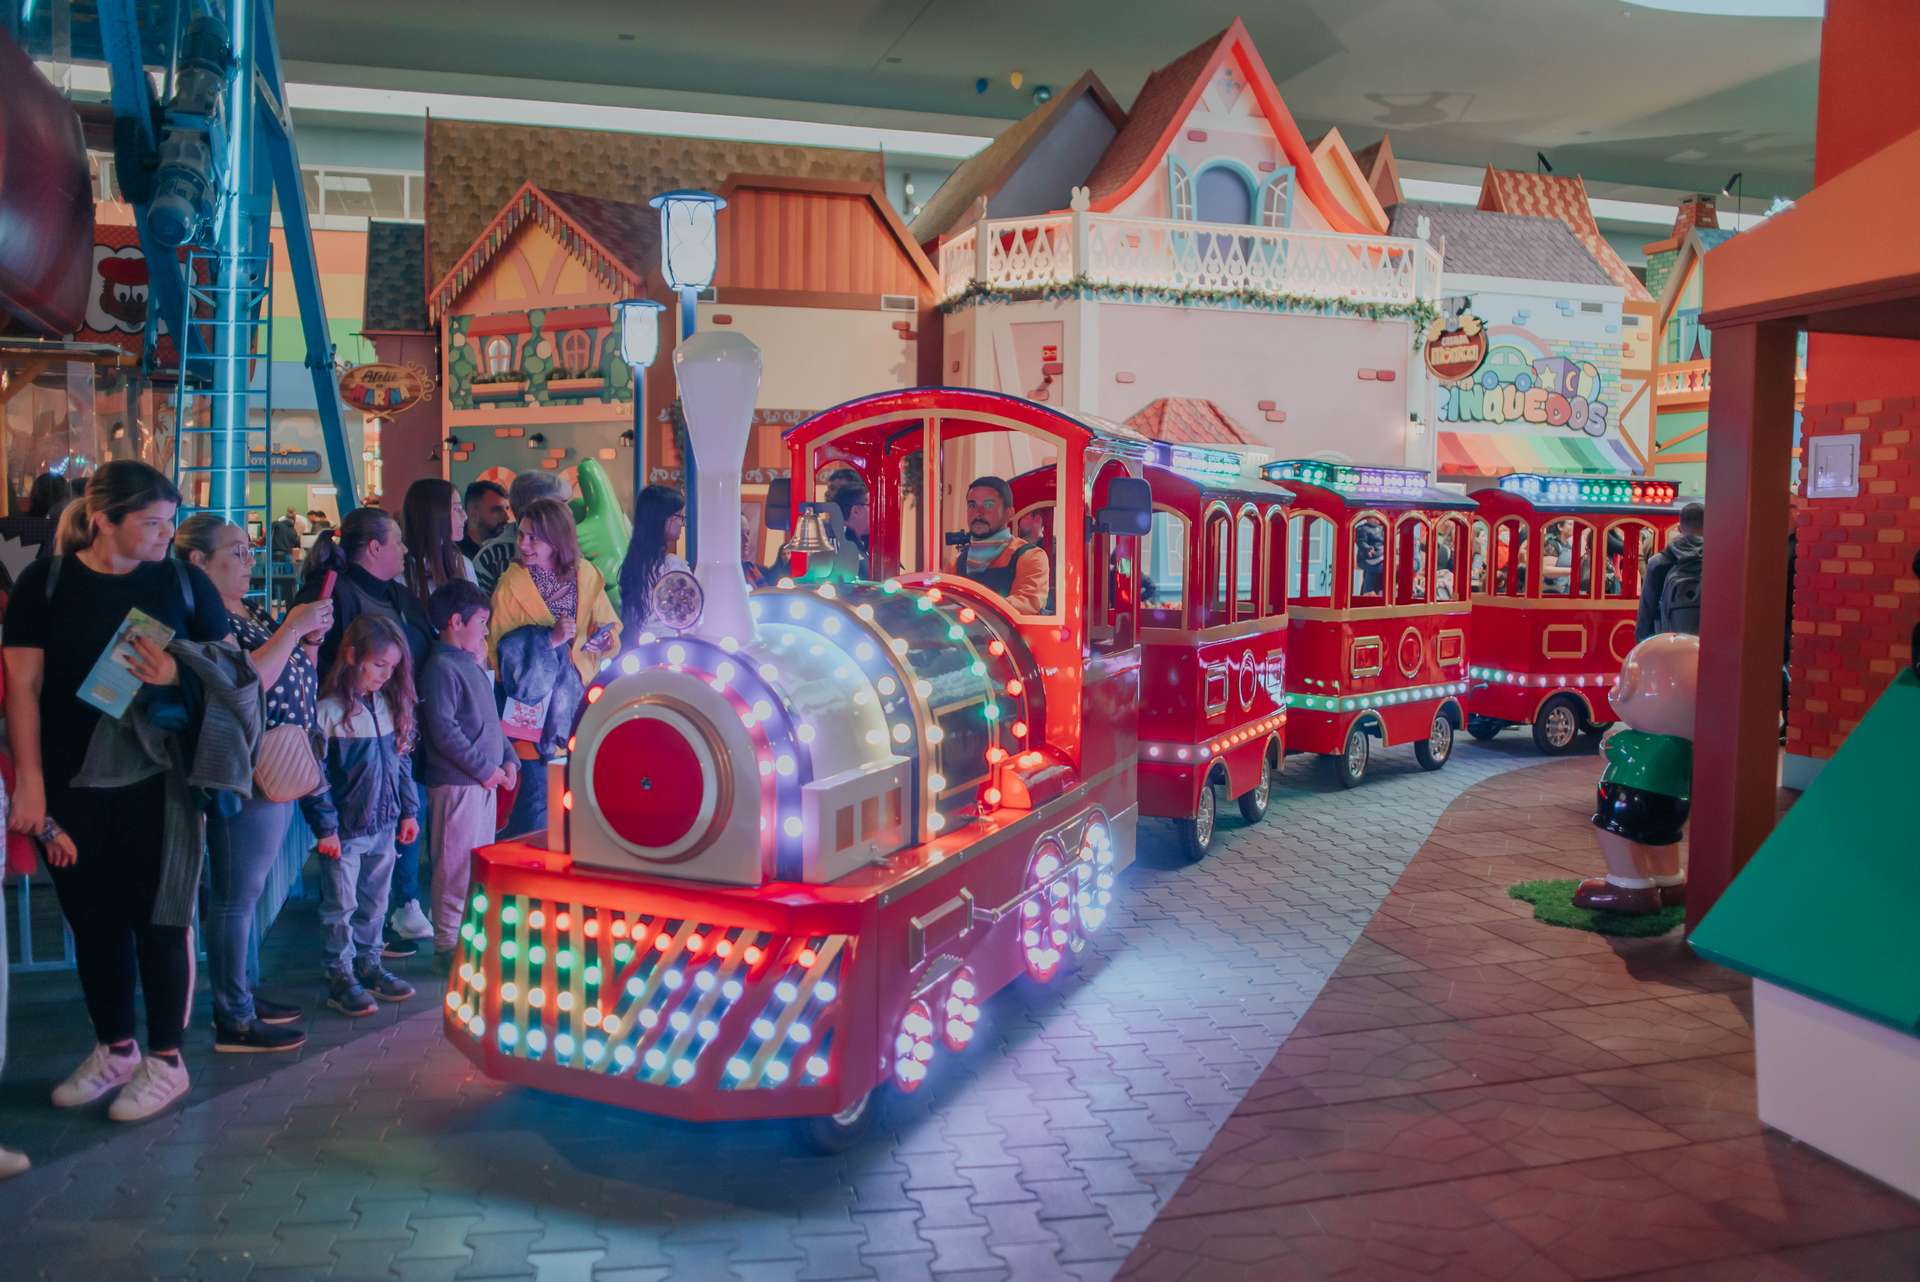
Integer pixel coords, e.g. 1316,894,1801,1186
1686,321,1799,929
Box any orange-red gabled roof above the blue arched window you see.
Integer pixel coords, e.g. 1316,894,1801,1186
1087,17,1371,234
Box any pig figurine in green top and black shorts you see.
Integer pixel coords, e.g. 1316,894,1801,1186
1572,631,1699,914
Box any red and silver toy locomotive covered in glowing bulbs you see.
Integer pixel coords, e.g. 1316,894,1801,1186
445,332,1150,1148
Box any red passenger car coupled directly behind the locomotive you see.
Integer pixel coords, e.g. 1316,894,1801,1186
1140,445,1292,860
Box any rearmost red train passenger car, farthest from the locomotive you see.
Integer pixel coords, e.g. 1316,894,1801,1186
1467,474,1680,756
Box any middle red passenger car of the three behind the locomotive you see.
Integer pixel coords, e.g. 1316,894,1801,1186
1263,459,1475,787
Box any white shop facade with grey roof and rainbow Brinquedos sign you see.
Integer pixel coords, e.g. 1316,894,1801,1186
1388,202,1645,487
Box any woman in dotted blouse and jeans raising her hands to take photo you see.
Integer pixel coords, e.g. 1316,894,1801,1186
173,512,334,1054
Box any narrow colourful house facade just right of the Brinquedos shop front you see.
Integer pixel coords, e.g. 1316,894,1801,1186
1647,196,1807,493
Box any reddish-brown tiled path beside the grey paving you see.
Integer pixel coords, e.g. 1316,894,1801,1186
1121,760,1920,1282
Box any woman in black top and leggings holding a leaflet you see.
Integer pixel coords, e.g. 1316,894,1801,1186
4,459,230,1121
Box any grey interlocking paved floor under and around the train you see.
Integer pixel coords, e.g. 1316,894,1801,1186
0,735,1543,1282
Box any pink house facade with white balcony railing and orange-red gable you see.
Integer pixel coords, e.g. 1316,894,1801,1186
914,21,1440,468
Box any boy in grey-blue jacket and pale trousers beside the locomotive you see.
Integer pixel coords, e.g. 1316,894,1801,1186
419,580,518,954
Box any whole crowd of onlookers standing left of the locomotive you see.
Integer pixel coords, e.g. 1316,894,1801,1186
0,461,685,1176
